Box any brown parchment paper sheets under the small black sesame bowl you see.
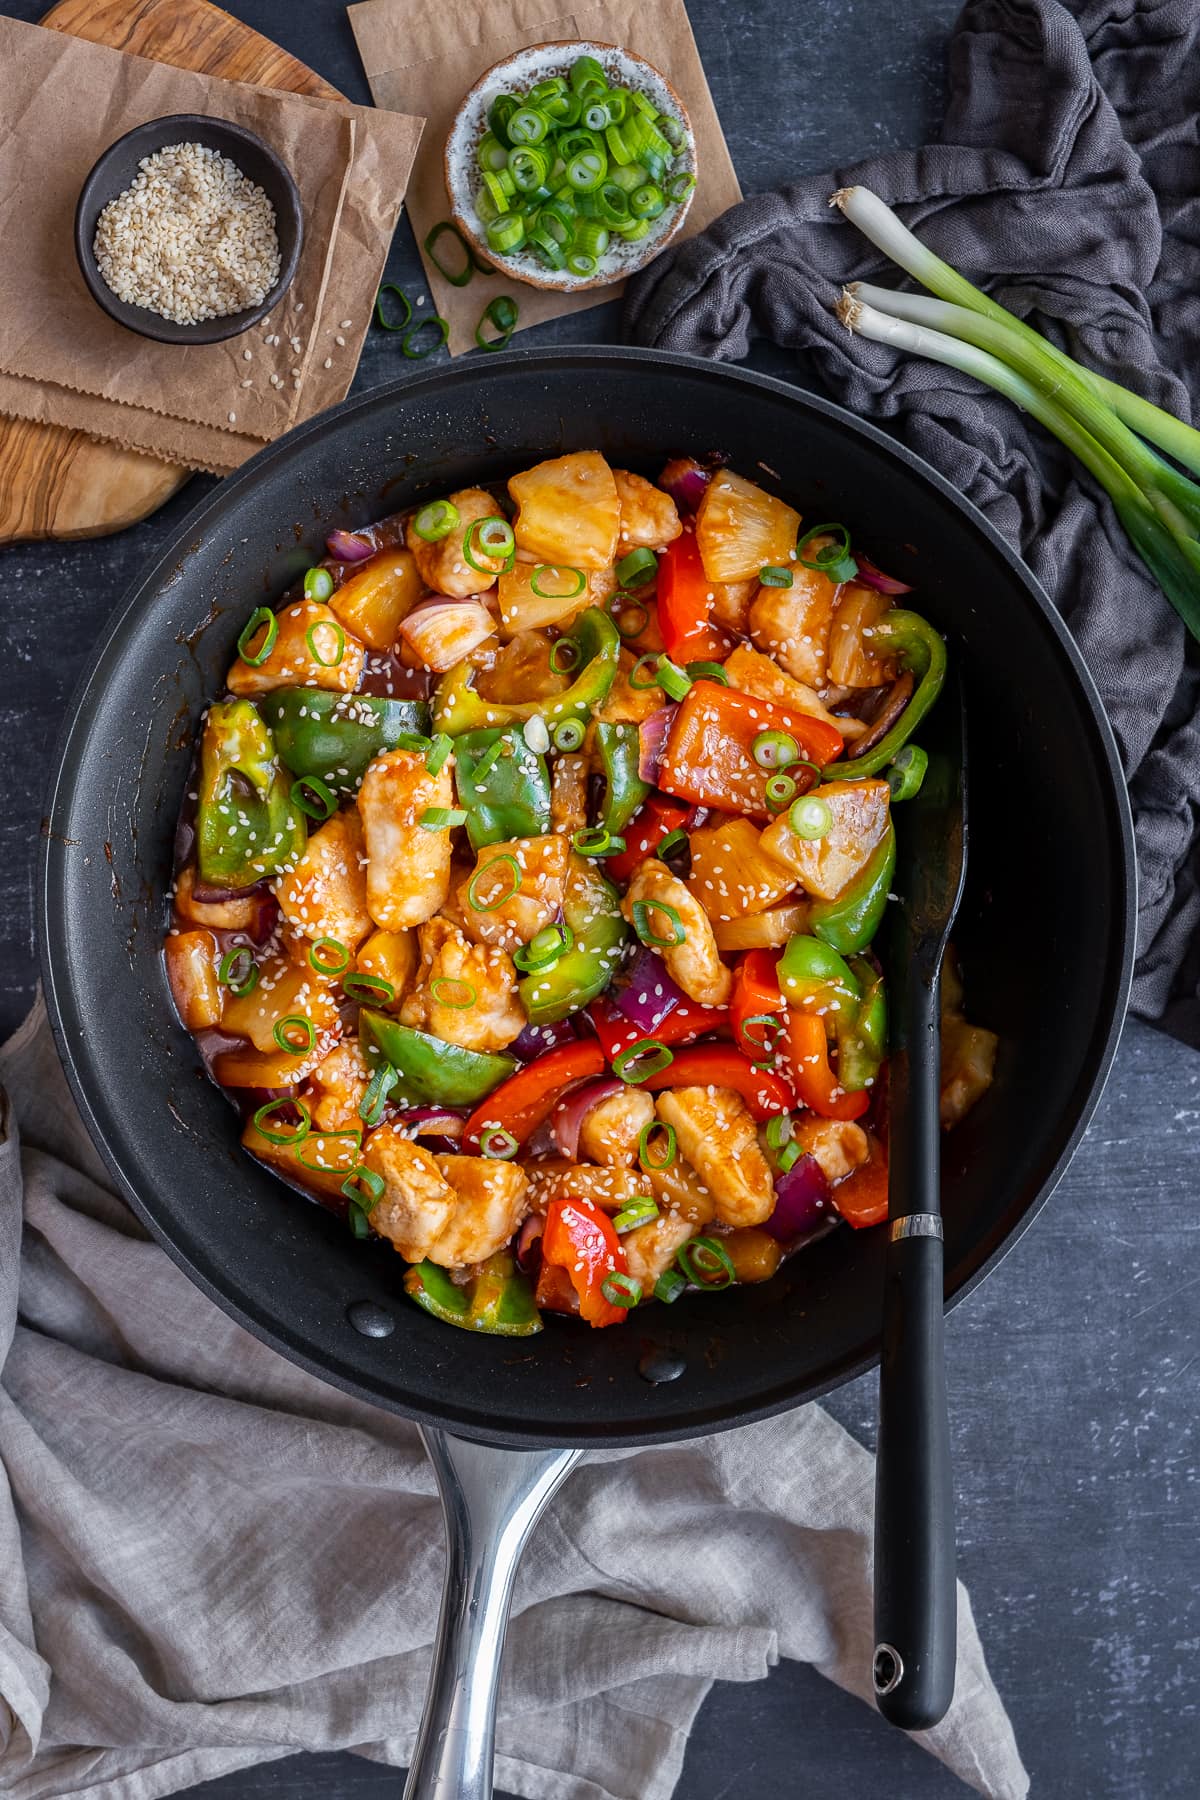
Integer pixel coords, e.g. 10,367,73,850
0,18,421,473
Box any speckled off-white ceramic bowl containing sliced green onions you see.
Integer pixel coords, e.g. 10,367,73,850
444,40,698,293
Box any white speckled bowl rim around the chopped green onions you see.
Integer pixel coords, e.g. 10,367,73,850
444,40,696,293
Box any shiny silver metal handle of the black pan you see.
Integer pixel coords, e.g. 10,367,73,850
405,1426,583,1800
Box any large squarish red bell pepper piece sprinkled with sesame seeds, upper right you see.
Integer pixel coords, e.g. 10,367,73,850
658,680,842,819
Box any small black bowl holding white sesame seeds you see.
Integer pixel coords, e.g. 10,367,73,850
76,113,304,344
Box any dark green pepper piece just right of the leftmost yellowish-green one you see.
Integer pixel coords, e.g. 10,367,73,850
259,688,430,794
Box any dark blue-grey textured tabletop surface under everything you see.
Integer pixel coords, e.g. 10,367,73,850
0,0,1200,1800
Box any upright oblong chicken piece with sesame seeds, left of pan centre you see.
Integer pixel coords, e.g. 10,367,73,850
358,751,453,931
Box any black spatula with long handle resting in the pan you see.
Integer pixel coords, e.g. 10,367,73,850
873,680,966,1732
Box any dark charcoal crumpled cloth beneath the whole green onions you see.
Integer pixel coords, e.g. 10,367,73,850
626,0,1200,1046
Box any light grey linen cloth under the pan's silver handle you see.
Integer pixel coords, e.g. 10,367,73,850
0,1004,1029,1800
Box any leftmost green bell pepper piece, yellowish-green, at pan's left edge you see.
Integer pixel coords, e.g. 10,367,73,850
196,700,308,887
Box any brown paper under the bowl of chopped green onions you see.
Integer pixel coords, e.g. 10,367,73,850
347,0,741,355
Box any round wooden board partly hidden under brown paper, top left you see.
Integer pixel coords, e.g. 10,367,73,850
0,0,342,544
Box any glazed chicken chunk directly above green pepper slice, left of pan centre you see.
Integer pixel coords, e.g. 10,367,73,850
399,918,527,1051
